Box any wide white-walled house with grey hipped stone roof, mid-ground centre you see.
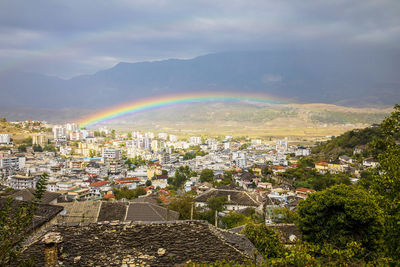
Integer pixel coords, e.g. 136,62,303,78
195,188,262,213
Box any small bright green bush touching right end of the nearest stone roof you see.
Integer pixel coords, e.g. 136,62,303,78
242,224,285,258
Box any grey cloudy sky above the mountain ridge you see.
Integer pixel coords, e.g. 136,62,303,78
0,0,400,78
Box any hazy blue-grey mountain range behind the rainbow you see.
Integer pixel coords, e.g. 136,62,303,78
0,51,400,111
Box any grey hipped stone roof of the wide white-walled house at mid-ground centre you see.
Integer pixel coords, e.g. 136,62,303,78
195,189,261,207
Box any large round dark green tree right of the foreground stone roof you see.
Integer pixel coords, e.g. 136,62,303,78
298,185,383,255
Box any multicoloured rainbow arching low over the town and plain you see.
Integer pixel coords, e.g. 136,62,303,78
77,92,288,128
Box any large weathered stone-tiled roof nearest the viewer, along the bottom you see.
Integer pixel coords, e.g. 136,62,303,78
22,221,256,266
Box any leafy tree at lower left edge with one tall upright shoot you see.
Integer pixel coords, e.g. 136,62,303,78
0,173,48,266
